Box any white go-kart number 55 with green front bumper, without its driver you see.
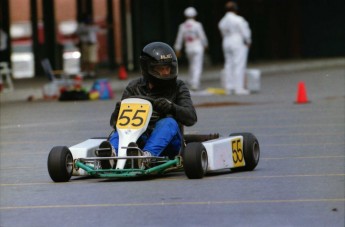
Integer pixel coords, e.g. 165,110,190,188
47,97,260,182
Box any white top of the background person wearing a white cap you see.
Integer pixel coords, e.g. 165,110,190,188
174,18,208,52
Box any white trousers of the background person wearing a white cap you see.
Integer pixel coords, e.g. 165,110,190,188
186,51,204,89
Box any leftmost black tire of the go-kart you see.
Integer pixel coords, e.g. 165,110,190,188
47,146,73,182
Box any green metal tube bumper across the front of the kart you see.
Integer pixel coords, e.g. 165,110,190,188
75,156,182,178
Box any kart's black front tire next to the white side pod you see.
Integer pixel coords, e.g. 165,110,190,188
182,142,208,179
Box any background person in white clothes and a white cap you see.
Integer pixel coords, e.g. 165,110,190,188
174,7,208,90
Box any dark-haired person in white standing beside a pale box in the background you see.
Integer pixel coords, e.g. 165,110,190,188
218,2,251,95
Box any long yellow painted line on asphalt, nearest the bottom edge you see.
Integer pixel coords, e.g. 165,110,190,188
0,198,345,210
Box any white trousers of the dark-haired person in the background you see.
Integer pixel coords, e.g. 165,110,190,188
221,46,248,91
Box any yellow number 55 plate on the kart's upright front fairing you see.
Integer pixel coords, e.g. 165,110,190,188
116,103,150,129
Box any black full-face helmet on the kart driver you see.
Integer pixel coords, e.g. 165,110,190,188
140,42,178,87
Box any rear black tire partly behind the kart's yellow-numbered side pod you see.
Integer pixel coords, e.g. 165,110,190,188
230,132,260,172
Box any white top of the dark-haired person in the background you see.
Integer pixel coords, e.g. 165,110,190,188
218,12,251,50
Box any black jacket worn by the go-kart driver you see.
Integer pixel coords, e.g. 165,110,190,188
122,77,197,126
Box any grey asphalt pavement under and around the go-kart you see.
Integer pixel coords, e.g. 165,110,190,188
0,58,345,227
